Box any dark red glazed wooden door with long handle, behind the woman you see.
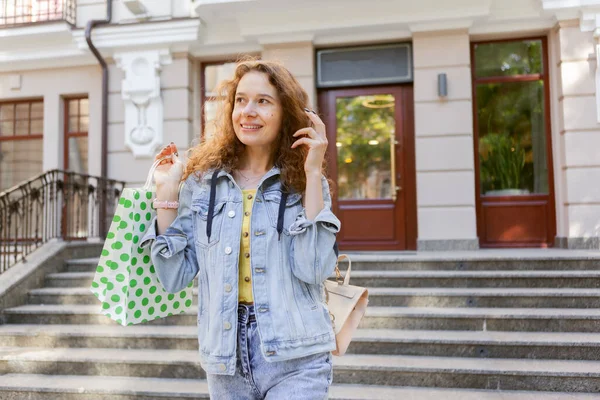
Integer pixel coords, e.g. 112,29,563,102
319,85,417,250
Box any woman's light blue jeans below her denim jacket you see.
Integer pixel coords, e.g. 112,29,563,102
206,304,333,400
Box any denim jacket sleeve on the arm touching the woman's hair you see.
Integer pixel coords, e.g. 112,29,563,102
289,176,341,284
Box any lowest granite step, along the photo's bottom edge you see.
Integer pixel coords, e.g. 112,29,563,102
0,374,597,400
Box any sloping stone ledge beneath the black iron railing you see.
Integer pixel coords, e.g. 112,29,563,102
0,239,102,324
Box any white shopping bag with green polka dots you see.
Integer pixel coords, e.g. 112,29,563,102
90,159,193,326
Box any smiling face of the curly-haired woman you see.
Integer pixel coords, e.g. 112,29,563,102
231,71,283,151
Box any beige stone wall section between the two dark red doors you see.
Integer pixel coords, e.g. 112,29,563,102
413,31,479,249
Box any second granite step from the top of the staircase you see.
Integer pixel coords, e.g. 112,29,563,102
46,270,600,288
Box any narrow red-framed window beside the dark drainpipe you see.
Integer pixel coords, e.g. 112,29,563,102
65,98,90,174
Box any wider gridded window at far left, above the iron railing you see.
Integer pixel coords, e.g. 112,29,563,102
0,100,44,191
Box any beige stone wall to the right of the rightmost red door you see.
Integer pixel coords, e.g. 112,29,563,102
550,21,600,249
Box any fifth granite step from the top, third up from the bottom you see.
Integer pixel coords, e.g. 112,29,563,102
0,324,600,361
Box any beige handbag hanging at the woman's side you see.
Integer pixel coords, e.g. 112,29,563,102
325,254,369,356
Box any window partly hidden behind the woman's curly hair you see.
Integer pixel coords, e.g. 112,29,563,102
201,62,236,139
